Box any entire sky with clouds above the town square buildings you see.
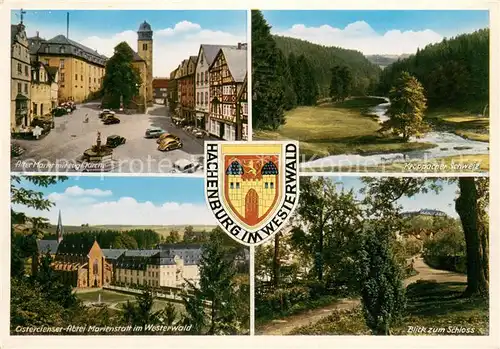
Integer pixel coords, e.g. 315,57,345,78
11,10,248,77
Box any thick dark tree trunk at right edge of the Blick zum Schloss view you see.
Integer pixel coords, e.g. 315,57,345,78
455,177,488,297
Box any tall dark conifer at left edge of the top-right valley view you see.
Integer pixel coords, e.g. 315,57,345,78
252,10,285,130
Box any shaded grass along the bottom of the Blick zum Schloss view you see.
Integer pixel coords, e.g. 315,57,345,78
292,281,489,335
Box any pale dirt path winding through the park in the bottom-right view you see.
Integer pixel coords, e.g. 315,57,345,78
256,257,467,335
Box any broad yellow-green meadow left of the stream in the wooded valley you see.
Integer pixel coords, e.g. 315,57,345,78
254,98,433,160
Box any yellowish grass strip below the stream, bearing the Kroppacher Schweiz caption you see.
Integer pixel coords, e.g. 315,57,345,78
303,154,490,173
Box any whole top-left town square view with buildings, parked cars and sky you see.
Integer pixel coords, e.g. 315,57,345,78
10,9,248,173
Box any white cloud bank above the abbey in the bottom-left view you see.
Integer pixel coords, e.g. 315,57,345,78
14,193,216,225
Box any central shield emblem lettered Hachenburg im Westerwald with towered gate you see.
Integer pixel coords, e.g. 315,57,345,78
205,141,299,245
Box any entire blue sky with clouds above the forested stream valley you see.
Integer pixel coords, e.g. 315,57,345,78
263,10,489,55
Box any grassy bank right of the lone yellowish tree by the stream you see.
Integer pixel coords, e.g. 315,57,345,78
426,109,490,142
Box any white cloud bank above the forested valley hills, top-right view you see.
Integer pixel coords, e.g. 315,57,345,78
273,21,443,55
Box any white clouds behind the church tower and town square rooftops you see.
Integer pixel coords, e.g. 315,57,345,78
28,20,247,77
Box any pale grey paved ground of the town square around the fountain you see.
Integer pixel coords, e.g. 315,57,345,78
11,103,203,173
